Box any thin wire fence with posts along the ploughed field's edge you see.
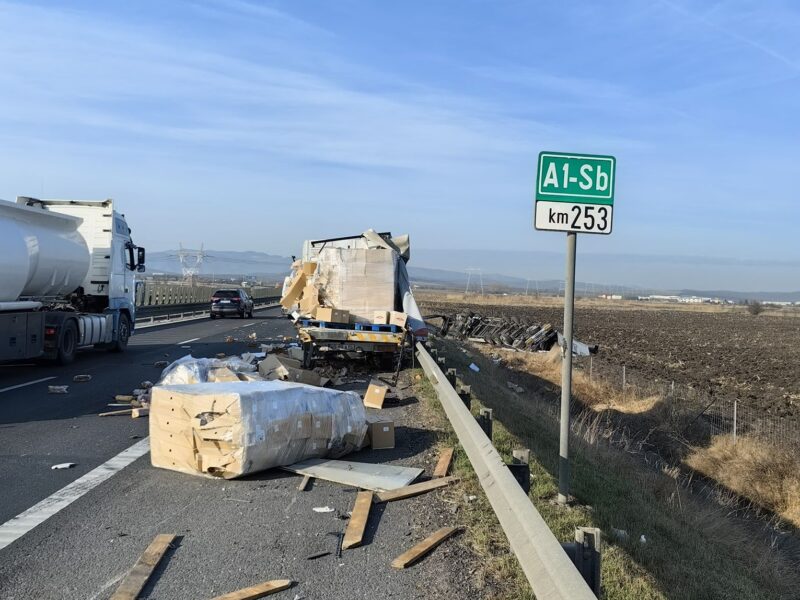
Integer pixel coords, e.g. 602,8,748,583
577,356,800,449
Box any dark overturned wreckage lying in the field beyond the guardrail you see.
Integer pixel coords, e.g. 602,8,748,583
440,311,598,356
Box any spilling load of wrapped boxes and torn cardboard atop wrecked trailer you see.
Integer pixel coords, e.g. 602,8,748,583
281,229,425,334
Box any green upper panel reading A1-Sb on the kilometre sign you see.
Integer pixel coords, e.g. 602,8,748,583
536,152,617,205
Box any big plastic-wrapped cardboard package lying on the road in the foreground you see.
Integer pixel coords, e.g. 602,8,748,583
150,381,367,479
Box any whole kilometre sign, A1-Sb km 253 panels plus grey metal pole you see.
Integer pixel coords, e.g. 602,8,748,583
534,152,617,504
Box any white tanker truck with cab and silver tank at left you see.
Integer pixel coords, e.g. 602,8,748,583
0,197,145,364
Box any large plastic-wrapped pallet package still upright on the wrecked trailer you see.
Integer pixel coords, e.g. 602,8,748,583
313,247,400,323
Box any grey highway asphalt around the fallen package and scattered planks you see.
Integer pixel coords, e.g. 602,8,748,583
0,309,482,600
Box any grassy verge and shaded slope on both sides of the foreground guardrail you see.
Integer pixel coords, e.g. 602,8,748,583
416,342,800,600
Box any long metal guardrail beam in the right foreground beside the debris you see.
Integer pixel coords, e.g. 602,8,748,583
417,343,596,600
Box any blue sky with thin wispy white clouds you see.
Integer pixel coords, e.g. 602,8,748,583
0,0,800,291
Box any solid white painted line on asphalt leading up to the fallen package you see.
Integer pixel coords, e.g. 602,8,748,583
0,438,150,550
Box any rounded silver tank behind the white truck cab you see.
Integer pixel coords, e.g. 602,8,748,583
0,200,89,302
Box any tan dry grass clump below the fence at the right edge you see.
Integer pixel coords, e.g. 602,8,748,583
686,435,800,527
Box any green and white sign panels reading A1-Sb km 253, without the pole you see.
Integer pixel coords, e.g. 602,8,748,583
534,152,617,235
